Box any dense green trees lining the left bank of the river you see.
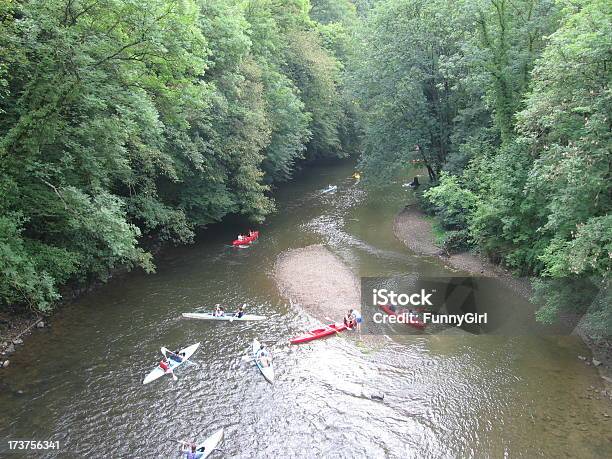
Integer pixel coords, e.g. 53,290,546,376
0,0,356,311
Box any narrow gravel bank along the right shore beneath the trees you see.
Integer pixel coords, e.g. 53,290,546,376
393,204,612,388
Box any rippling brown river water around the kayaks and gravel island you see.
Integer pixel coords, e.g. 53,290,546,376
0,162,612,458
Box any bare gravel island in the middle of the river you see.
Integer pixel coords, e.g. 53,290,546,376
273,245,361,322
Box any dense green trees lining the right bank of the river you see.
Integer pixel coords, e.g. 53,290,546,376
354,0,612,335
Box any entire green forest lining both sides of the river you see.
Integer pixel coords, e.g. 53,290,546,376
0,0,612,336
